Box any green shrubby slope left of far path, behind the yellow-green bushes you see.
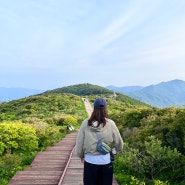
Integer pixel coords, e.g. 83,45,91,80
0,94,86,121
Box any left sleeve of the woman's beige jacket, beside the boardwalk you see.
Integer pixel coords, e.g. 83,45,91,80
75,120,84,158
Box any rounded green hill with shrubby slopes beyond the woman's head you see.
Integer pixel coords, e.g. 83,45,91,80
0,83,148,121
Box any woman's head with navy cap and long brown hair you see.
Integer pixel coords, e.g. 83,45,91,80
88,98,108,126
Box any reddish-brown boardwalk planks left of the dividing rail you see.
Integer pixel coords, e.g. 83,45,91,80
8,132,80,185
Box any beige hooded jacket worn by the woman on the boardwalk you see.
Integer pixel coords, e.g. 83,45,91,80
75,119,123,158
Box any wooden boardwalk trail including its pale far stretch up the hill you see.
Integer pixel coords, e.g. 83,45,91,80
8,98,118,185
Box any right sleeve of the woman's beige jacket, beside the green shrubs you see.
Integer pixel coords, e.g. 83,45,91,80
113,120,124,152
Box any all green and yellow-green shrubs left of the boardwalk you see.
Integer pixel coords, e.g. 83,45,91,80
0,94,87,185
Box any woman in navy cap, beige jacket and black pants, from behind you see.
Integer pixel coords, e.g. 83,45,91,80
76,98,123,185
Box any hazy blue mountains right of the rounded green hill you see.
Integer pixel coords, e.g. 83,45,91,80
107,80,185,108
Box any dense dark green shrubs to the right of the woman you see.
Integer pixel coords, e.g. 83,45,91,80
110,107,185,185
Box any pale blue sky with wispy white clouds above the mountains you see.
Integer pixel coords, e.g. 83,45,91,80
0,0,185,90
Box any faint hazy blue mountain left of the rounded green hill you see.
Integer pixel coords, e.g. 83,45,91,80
0,87,43,102
